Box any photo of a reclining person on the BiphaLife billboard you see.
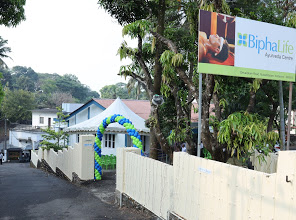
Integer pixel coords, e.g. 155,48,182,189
198,10,235,66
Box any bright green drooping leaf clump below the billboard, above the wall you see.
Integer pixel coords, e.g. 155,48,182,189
218,112,279,158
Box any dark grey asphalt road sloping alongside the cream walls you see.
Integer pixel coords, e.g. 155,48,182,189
0,163,153,220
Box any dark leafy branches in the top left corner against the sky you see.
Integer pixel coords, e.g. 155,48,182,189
0,0,26,27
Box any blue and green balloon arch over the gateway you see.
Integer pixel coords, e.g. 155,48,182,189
94,114,143,180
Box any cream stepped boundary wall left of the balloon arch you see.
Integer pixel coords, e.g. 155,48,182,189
31,135,94,180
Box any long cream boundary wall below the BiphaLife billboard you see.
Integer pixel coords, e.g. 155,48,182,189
116,148,296,220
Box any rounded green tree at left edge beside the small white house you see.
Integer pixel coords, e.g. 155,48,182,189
2,89,35,123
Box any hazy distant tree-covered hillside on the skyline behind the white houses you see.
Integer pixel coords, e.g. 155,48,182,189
0,66,100,108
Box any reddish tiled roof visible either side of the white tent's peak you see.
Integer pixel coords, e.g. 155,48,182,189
93,99,151,120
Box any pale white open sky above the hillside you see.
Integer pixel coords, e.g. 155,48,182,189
0,0,136,92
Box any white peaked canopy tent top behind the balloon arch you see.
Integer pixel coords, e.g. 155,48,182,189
64,98,150,134
